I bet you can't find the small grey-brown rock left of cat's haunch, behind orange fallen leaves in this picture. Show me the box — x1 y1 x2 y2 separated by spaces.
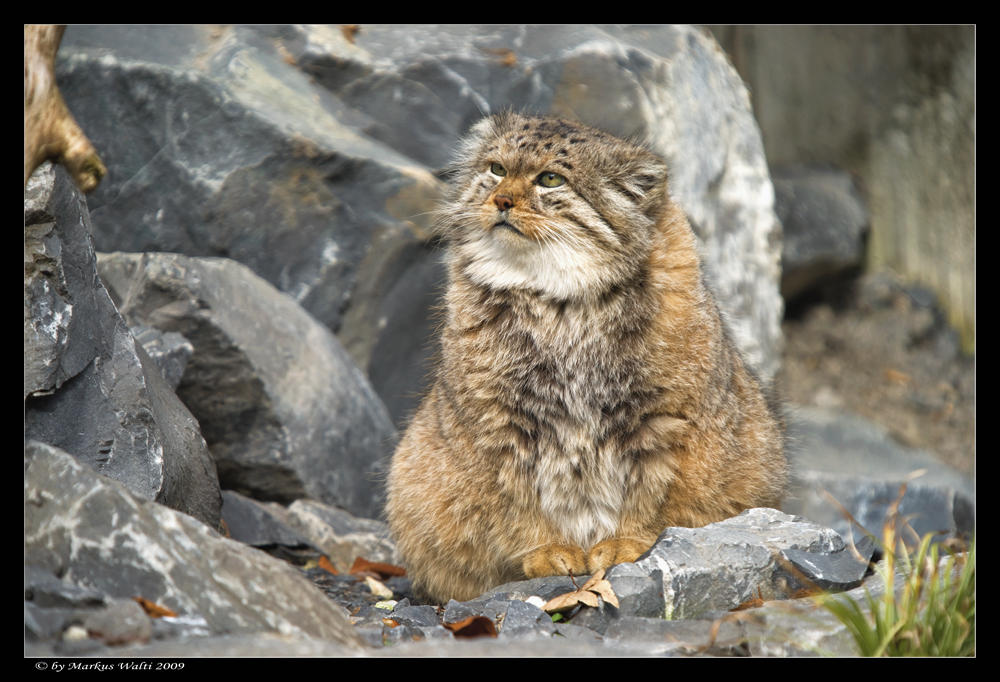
286 500 397 573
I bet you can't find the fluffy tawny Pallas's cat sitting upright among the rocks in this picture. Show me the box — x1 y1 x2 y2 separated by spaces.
387 113 787 603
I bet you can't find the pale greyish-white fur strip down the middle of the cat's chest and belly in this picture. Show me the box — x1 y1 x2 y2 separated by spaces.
482 300 634 547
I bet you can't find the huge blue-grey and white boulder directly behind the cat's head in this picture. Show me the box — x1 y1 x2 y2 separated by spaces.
58 26 783 432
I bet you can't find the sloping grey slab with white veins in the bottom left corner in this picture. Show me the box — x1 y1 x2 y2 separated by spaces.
24 442 360 647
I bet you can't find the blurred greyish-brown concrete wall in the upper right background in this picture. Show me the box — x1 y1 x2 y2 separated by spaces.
707 25 976 352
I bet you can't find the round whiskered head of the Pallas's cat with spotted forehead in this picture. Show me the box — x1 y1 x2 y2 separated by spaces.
444 114 666 300
